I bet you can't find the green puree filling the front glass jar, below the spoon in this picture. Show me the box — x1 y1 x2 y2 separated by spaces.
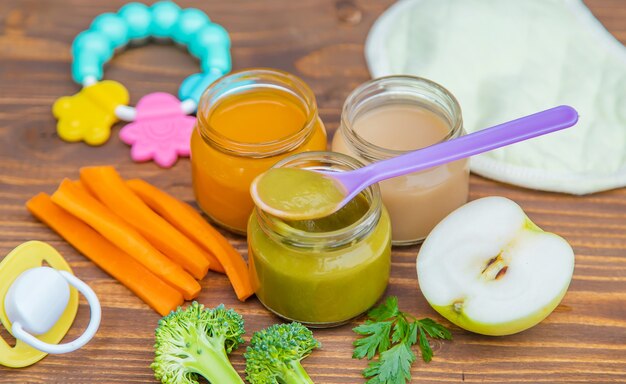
248 195 391 325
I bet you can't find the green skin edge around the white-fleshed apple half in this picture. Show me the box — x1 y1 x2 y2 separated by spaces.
418 198 573 336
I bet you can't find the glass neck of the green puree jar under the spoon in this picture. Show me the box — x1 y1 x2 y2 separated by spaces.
255 152 382 250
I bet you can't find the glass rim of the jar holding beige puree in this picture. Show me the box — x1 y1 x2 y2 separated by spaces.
337 75 464 161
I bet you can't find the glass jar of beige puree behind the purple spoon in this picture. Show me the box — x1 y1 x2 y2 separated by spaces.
332 76 469 245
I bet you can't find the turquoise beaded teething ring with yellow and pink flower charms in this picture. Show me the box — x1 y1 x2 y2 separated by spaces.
53 1 231 167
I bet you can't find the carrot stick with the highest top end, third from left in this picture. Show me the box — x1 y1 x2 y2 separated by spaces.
80 166 210 280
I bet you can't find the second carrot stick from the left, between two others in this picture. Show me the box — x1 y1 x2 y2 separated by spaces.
52 179 200 300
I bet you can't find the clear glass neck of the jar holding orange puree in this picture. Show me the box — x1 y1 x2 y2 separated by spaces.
196 68 318 158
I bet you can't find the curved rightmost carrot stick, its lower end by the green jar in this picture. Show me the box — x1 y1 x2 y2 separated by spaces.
126 179 254 301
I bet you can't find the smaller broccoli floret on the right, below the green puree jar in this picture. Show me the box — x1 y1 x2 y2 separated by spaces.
244 322 321 384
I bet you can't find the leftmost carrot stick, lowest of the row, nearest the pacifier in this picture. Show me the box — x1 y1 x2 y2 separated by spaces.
26 193 183 316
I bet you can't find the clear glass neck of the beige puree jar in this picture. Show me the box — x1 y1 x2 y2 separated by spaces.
338 76 465 162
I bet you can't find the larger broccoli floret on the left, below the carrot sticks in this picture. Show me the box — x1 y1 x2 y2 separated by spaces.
150 301 245 384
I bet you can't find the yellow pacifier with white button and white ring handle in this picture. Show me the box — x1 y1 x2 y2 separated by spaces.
0 241 101 368
